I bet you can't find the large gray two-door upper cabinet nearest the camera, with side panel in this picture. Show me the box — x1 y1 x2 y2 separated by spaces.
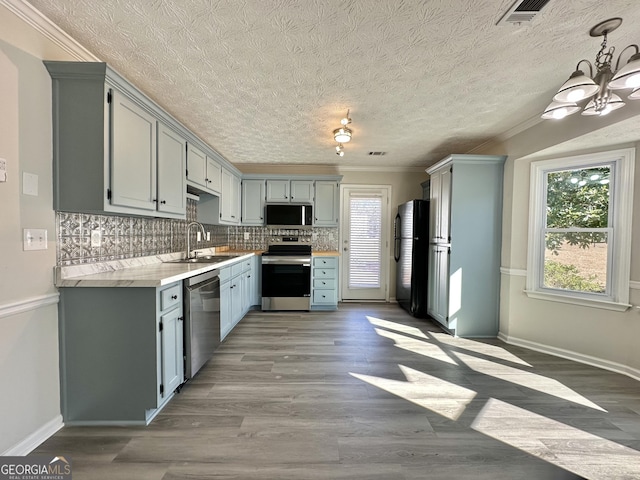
44 61 186 218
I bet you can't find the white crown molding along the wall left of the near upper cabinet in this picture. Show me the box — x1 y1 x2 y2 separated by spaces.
0 0 100 62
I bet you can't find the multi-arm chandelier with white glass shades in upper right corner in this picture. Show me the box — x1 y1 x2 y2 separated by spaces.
542 17 640 119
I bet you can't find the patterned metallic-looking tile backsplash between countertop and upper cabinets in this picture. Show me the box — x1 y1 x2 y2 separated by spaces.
56 199 338 266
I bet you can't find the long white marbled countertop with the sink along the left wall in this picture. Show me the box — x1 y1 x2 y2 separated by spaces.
55 252 255 287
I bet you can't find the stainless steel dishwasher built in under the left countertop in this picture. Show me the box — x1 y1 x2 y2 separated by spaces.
184 270 220 379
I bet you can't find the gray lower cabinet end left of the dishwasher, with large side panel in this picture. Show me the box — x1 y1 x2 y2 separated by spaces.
59 282 184 425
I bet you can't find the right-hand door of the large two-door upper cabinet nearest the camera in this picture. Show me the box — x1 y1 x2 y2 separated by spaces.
157 122 187 215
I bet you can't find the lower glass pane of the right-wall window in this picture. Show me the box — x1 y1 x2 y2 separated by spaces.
544 232 608 293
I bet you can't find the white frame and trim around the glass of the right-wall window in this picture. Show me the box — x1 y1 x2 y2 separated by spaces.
525 148 635 311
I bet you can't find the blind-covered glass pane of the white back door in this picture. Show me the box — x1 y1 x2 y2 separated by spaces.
348 197 382 288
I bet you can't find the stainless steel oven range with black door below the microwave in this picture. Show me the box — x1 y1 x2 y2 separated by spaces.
262 236 311 310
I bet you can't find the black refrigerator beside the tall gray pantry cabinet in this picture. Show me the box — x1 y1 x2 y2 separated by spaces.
393 200 429 318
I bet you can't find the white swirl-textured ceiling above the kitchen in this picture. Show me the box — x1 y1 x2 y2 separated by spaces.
22 0 640 167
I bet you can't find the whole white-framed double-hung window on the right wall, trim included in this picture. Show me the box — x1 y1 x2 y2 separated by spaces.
527 149 635 310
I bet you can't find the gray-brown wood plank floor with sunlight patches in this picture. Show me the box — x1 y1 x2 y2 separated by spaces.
33 304 640 480
